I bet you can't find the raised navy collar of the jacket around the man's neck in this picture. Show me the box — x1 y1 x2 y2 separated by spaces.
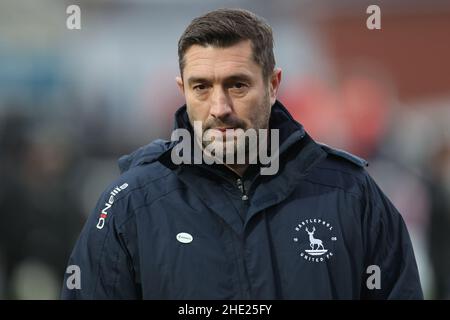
161 101 326 234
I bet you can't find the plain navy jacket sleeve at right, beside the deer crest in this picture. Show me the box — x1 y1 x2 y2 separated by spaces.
361 175 423 299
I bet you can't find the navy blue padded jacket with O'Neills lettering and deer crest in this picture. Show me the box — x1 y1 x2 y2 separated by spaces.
62 101 423 299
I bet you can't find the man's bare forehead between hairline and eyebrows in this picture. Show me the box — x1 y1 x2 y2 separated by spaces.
183 40 261 79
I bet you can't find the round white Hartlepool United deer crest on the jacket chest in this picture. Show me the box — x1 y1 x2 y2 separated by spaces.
293 218 337 263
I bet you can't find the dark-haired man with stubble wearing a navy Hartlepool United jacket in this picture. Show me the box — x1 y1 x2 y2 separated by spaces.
62 9 422 299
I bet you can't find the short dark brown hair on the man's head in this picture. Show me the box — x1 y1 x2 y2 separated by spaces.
178 9 275 79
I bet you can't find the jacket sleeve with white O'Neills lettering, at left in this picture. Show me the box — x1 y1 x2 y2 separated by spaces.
61 187 140 299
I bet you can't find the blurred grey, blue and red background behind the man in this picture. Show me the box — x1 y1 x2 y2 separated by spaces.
0 0 450 299
